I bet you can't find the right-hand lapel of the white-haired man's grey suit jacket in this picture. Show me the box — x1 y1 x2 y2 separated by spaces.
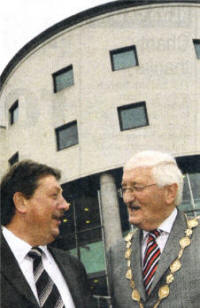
150 211 186 293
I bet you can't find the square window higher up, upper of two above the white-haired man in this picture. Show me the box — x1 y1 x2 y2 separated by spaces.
110 45 138 71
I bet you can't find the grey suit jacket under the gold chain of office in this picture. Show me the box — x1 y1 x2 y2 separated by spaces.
109 211 200 308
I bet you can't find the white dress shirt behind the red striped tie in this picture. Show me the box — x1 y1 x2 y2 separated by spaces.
142 208 177 264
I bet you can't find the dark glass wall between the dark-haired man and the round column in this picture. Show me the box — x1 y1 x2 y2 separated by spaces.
50 177 109 308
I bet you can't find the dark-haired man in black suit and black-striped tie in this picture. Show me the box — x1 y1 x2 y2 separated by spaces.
1 160 93 308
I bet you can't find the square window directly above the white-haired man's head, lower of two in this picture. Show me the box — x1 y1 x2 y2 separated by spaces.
118 102 149 131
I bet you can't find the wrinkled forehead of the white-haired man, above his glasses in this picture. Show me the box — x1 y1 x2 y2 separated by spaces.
122 167 153 185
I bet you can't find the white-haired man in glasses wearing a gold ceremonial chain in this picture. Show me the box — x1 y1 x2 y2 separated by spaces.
109 151 200 308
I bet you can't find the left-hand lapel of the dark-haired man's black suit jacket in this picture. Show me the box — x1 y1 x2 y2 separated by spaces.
1 234 38 306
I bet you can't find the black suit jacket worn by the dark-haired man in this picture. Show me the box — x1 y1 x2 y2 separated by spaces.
1 234 94 308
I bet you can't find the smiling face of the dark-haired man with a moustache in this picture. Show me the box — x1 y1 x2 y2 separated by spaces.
19 175 69 246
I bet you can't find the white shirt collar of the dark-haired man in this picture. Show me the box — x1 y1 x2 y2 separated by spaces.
2 226 49 264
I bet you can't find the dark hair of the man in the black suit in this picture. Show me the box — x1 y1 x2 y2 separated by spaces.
0 160 61 225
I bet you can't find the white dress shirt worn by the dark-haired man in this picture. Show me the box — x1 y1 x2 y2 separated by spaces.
2 227 75 308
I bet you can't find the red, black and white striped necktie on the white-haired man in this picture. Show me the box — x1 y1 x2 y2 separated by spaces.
143 230 161 294
